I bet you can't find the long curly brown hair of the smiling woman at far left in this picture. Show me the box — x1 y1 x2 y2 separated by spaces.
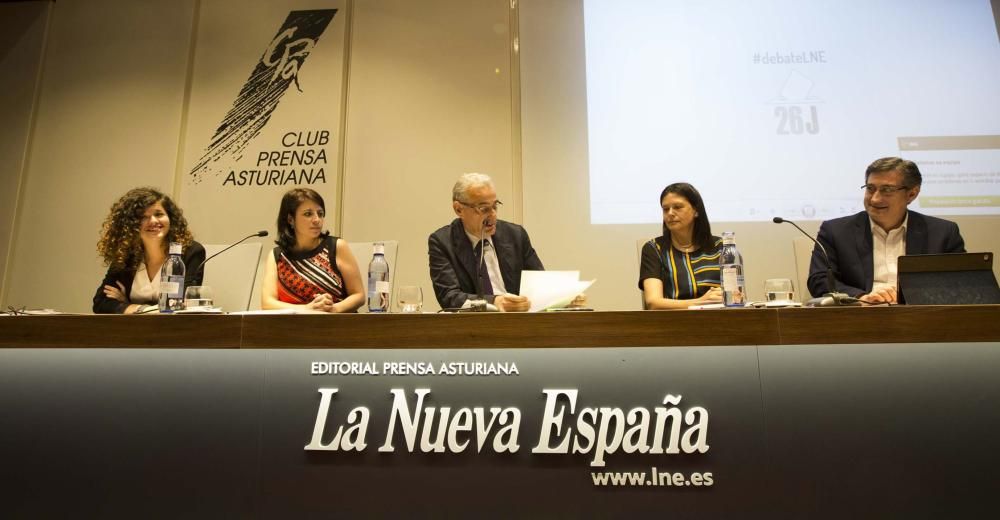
97 187 194 270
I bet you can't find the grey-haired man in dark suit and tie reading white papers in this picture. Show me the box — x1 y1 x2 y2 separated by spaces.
427 173 545 312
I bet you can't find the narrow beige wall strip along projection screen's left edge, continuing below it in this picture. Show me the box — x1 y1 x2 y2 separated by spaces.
520 1 644 309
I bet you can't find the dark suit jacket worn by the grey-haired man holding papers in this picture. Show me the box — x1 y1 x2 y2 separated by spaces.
427 219 545 309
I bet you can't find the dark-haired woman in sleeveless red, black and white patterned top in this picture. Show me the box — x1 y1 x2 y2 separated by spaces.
261 188 365 312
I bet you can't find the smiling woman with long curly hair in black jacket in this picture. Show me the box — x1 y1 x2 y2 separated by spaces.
94 188 205 314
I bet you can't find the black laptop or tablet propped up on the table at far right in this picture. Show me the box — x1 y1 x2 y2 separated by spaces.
896 253 1000 305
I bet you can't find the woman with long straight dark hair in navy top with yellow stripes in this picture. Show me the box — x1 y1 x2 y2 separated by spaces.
639 182 722 309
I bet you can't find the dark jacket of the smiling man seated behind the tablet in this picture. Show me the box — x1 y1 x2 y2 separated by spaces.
809 211 965 297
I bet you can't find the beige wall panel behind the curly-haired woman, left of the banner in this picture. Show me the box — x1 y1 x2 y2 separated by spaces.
4 0 195 312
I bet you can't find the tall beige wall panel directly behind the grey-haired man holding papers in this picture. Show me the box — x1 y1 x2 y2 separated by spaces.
342 0 519 309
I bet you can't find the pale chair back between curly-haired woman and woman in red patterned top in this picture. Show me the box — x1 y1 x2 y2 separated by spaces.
202 243 261 312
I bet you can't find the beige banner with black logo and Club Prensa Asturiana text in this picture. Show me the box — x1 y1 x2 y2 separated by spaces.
180 0 346 242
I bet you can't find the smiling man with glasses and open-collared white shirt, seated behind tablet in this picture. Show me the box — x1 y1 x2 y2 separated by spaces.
809 157 965 303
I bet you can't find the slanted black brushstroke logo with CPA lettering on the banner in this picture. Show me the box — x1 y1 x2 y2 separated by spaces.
189 9 337 184
